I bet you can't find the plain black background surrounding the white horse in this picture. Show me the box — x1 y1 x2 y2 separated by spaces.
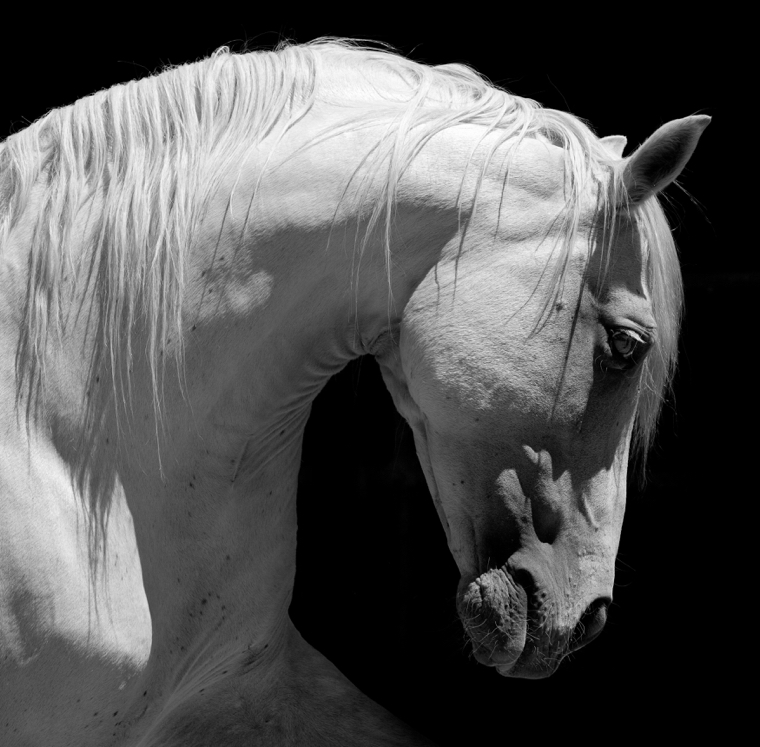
0 16 744 745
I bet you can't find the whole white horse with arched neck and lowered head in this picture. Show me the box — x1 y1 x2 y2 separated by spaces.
0 41 709 747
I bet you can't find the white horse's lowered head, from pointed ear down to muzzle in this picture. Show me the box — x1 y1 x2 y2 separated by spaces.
378 116 709 678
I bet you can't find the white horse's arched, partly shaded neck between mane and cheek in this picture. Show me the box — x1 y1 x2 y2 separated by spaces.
125 120 472 646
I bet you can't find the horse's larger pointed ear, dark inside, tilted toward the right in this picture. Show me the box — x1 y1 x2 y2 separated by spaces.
623 114 710 205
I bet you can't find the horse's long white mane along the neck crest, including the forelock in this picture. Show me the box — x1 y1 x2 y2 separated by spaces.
0 39 682 462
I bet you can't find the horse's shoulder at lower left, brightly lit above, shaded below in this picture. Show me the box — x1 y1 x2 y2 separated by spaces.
0 424 150 745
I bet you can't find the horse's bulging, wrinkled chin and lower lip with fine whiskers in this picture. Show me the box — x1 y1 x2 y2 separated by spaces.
457 568 561 679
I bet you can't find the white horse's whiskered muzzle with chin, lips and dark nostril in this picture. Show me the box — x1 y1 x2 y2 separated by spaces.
457 566 611 679
